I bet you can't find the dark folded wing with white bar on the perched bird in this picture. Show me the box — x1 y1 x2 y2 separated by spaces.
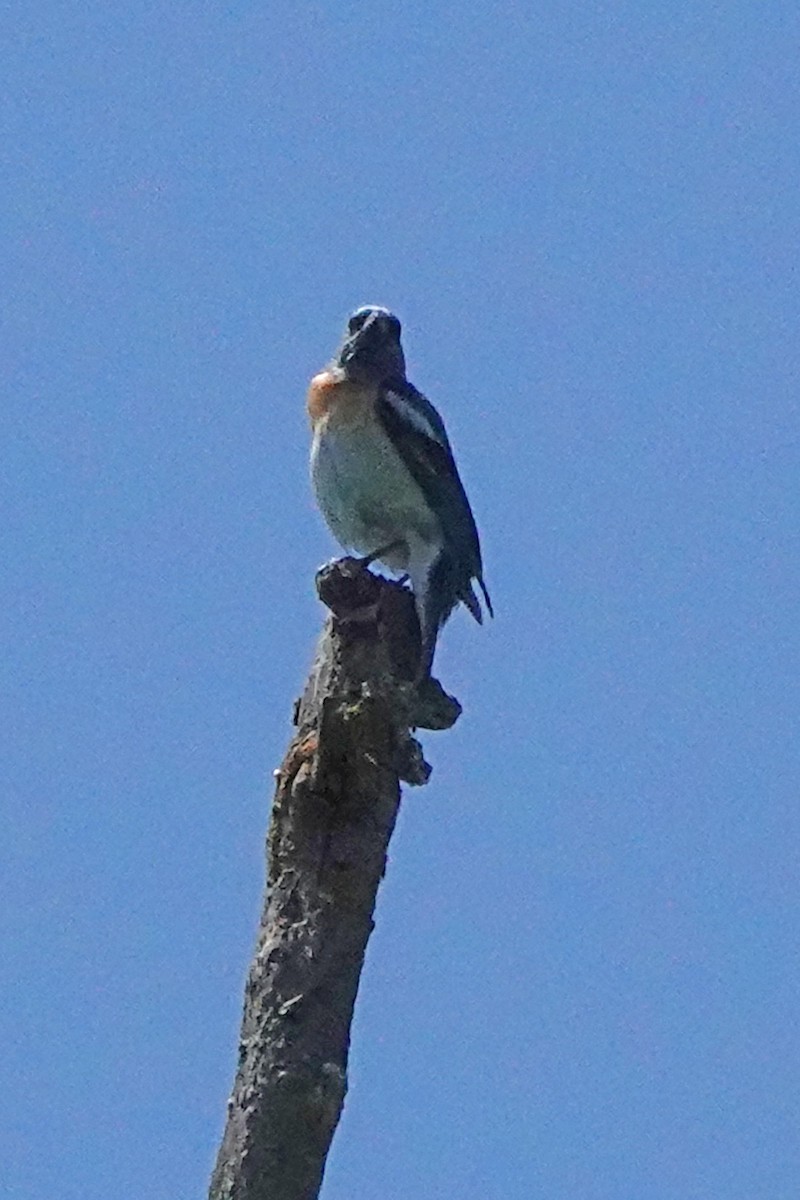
377 380 491 597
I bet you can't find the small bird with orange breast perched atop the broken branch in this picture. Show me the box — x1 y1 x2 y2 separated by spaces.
307 305 494 683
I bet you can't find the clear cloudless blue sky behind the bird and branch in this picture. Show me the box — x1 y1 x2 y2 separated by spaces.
0 0 800 1200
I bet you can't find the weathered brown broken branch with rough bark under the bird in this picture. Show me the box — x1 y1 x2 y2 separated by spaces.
210 559 461 1200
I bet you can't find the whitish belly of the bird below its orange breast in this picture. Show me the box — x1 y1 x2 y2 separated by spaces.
311 412 440 571
